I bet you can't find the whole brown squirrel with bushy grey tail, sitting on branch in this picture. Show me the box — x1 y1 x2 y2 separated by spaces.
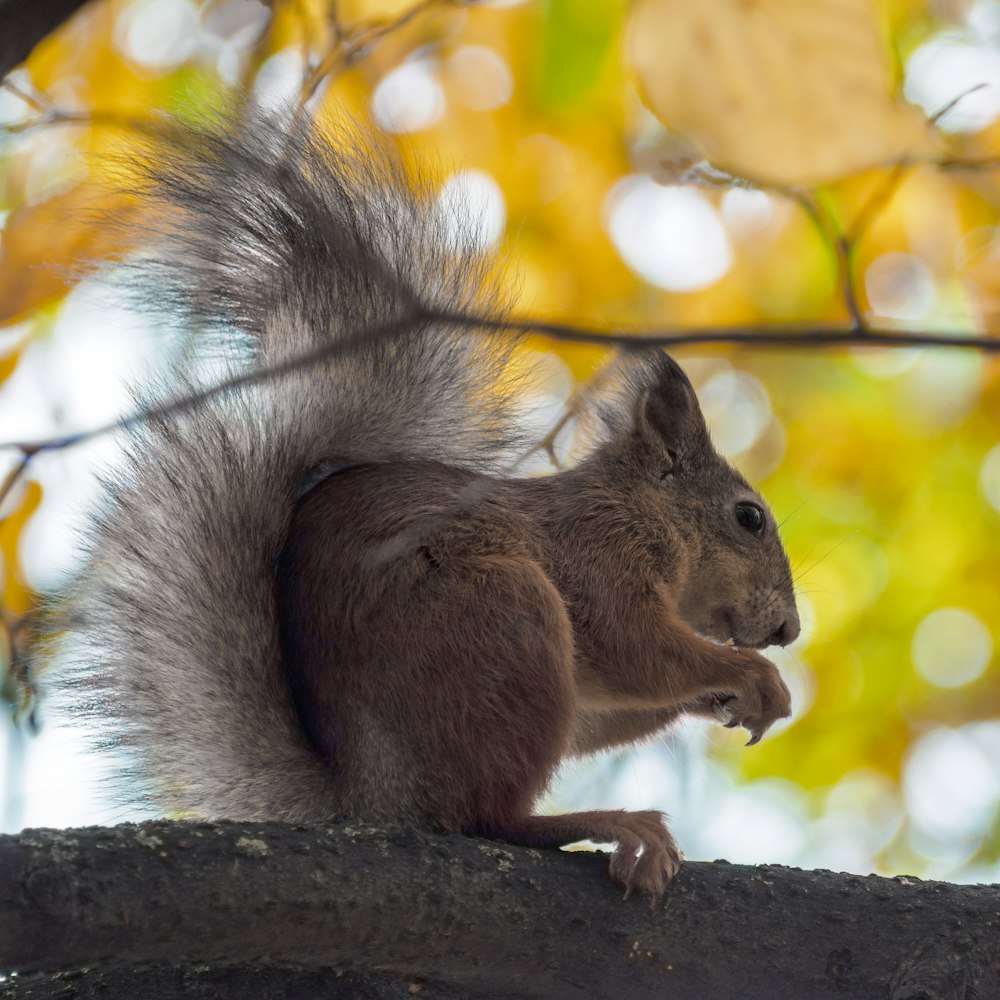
55 111 799 898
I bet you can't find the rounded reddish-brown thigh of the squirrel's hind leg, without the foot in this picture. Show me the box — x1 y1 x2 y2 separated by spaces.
316 544 576 832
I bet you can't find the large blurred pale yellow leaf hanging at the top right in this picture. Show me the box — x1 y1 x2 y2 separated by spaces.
629 0 929 186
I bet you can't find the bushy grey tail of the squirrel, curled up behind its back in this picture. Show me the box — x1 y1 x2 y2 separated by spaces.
57 107 513 821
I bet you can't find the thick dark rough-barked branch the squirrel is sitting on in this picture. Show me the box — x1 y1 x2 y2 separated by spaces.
0 822 1000 1000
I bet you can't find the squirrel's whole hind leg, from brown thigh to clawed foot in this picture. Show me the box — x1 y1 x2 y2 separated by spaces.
341 539 680 896
